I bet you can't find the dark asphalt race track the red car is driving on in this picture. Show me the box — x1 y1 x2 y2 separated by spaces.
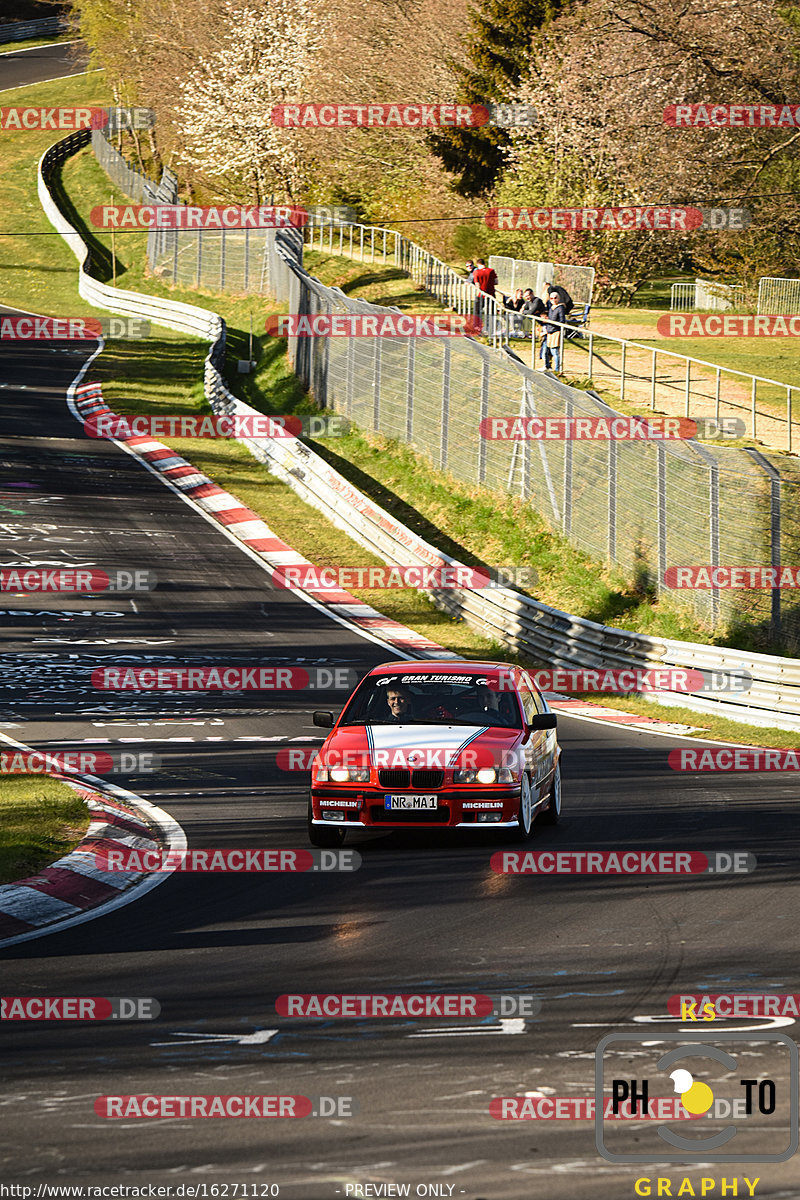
0 42 800 1200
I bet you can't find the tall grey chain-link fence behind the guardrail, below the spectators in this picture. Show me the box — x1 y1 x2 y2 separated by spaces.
90 136 800 652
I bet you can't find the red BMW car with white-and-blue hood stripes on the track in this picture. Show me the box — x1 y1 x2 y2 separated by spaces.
308 659 561 847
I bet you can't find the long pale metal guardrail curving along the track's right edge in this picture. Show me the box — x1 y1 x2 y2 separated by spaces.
40 131 800 731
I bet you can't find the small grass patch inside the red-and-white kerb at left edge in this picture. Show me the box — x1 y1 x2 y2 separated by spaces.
0 775 89 883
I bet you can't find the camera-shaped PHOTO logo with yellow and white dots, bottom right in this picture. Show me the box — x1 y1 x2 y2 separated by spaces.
595 1028 800 1163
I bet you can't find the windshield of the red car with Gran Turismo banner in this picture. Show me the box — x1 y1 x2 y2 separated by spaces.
341 672 522 730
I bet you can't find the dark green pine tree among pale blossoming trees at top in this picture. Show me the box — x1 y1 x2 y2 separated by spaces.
429 0 559 197
